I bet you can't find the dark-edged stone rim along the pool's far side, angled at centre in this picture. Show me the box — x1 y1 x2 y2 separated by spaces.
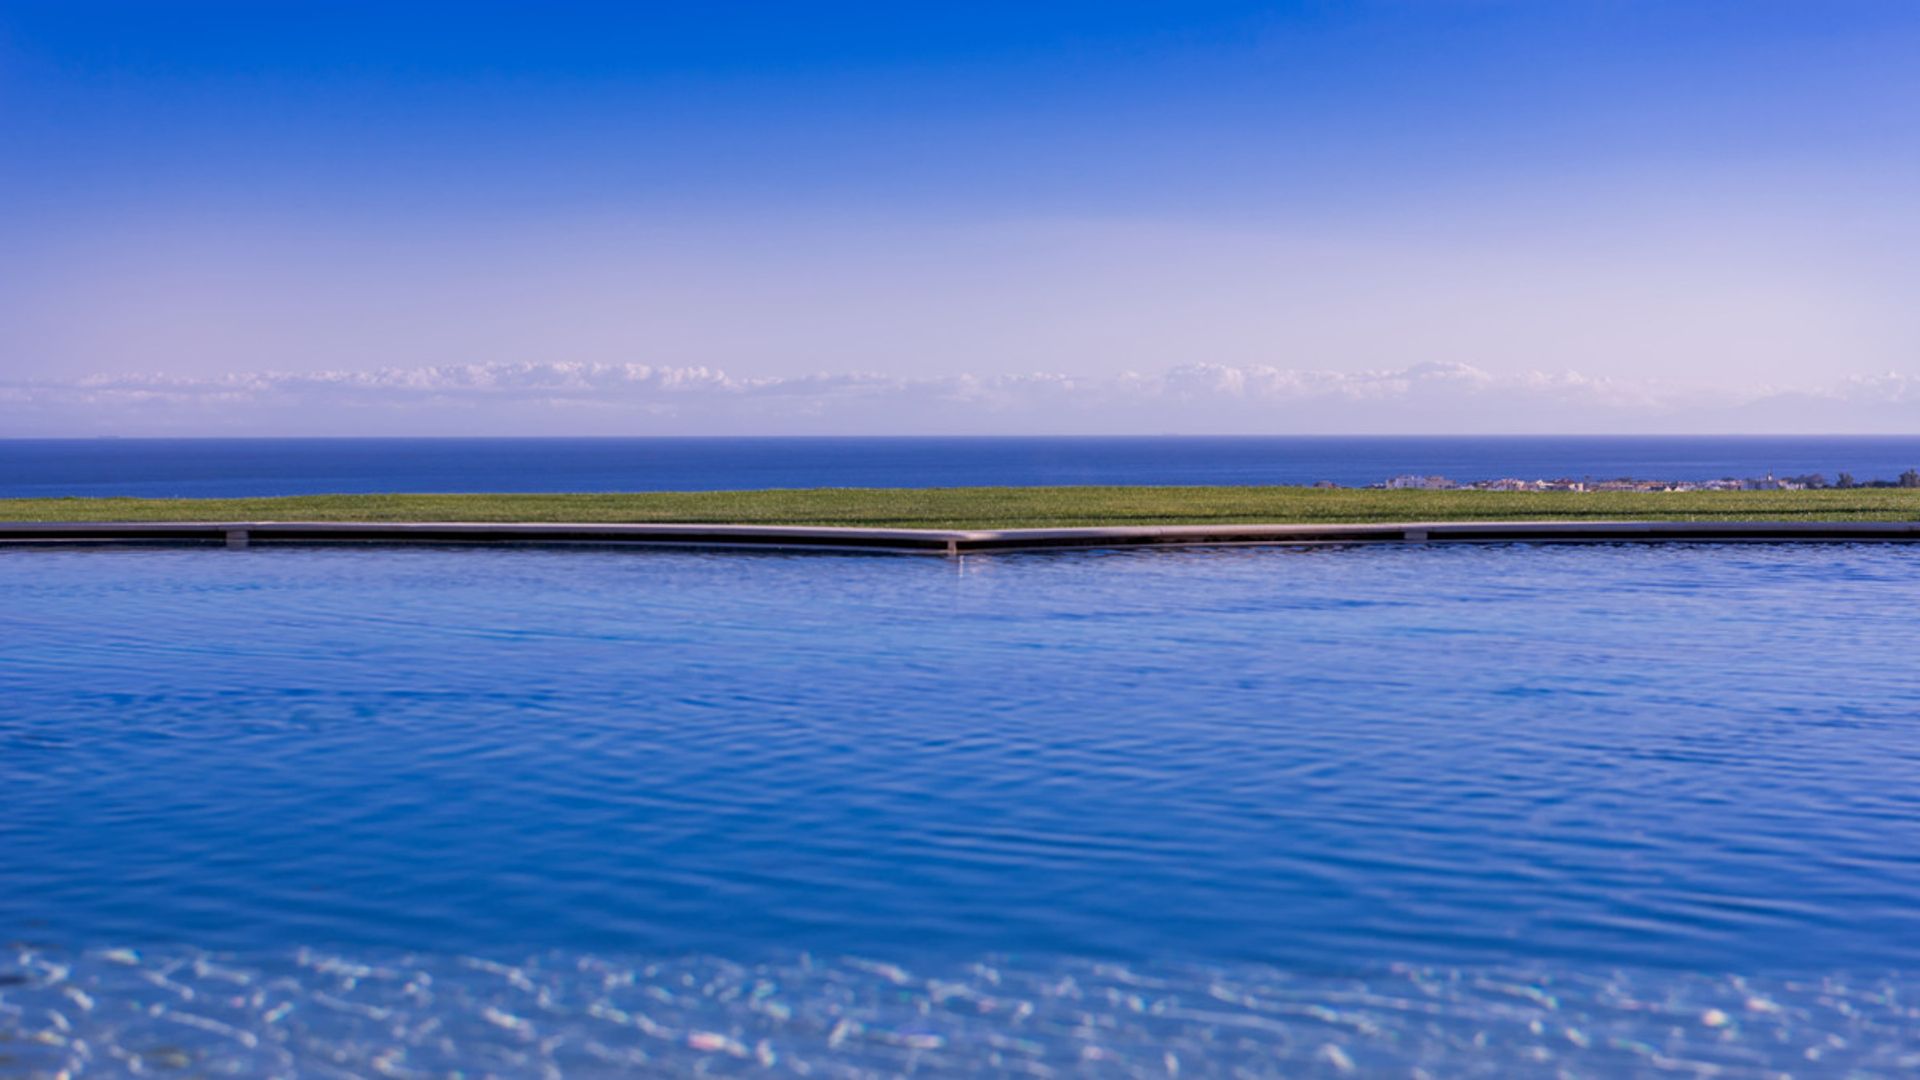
0 521 1920 555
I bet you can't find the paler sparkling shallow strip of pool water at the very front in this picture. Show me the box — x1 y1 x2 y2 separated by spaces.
11 949 1920 1076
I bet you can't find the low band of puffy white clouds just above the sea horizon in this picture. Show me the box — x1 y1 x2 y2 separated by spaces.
0 363 1920 436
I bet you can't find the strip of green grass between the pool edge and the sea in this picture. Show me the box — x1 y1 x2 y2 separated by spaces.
0 488 1920 528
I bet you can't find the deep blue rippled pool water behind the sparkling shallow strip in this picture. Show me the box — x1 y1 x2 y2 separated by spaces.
0 546 1920 972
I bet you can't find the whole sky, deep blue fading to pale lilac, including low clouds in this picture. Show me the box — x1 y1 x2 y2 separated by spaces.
0 0 1920 434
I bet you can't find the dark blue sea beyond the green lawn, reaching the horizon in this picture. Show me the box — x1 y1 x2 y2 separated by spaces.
11 436 1920 498
